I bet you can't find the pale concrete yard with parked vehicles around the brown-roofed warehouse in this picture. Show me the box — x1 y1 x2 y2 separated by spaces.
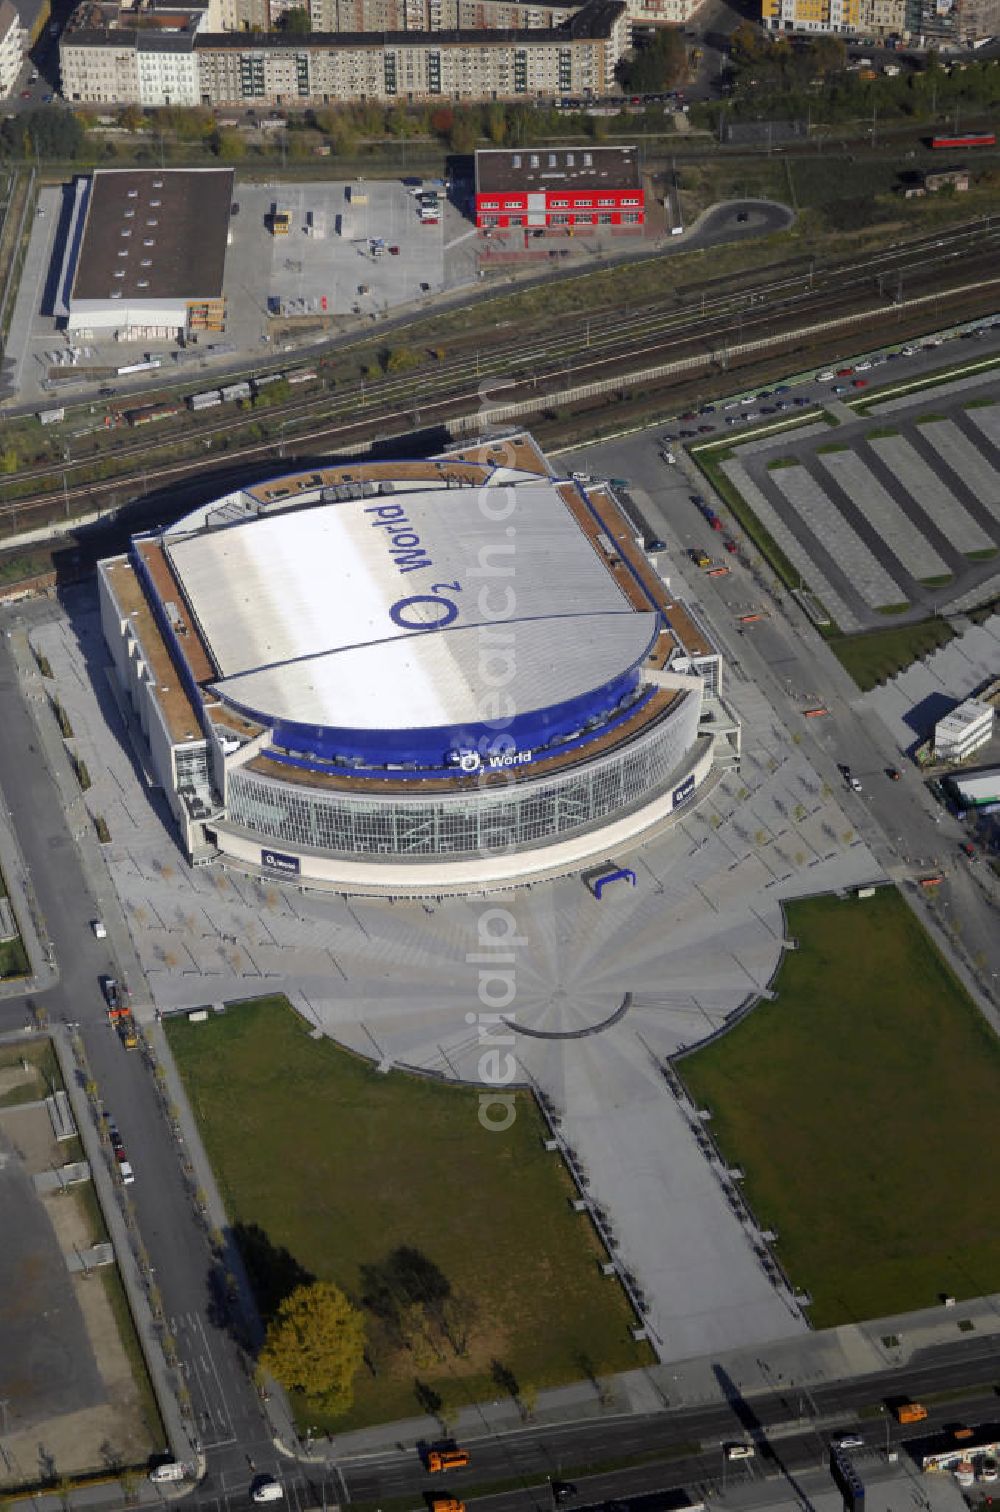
0 180 478 404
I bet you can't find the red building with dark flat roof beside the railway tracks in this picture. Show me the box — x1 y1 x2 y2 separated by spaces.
475 147 646 234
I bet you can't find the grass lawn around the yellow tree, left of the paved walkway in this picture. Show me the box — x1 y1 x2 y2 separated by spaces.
168 998 651 1429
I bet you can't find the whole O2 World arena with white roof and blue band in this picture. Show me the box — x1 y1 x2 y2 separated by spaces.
98 435 740 895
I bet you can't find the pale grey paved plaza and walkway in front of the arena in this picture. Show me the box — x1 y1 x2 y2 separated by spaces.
32 590 879 1359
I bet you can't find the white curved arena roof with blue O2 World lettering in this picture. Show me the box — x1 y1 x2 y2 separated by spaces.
163 481 657 729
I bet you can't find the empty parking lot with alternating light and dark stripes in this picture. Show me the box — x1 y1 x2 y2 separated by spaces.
720 375 1000 634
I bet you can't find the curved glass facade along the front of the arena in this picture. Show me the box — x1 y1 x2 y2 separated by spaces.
227 692 700 856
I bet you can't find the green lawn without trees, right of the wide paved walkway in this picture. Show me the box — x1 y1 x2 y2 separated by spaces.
679 888 1000 1328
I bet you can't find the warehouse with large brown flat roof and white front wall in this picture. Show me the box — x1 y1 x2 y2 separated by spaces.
56 168 234 340
